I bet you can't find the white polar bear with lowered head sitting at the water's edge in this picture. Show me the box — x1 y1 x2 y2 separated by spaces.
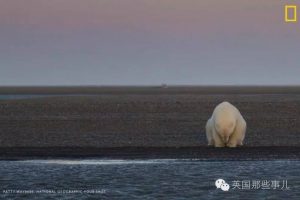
206 101 247 147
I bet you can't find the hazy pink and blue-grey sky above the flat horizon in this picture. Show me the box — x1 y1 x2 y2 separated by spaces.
0 0 300 86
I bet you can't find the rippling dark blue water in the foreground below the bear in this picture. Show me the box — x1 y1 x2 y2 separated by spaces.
0 159 300 200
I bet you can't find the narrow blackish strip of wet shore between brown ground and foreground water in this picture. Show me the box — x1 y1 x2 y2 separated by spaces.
0 146 300 161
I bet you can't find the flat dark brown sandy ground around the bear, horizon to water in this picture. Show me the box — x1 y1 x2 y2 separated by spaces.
0 87 300 159
